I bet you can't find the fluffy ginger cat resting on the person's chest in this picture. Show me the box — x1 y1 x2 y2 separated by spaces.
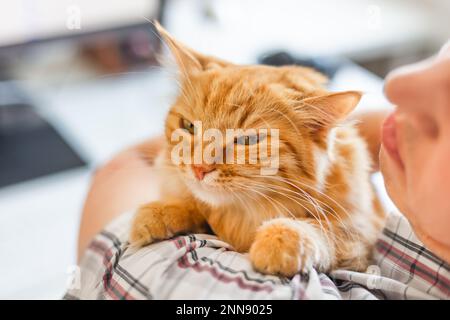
129 25 384 277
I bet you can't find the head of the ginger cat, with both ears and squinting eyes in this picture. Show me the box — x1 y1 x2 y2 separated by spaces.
156 23 359 205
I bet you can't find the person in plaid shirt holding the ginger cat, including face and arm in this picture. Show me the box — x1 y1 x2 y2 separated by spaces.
65 42 450 299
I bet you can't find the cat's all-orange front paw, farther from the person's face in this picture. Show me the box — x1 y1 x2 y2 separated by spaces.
129 201 191 247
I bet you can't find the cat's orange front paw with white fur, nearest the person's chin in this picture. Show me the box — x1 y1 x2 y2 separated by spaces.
249 218 330 277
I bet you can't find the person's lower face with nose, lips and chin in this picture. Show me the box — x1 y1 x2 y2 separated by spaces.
380 42 450 262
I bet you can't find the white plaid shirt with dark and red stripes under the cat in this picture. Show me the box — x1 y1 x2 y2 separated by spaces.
64 213 450 299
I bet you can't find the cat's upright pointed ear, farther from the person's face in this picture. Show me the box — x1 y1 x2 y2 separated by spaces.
154 21 231 74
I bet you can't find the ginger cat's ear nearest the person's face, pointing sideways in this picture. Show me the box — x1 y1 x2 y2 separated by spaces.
298 91 362 126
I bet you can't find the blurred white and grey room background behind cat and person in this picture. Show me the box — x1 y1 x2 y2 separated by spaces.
0 0 450 299
